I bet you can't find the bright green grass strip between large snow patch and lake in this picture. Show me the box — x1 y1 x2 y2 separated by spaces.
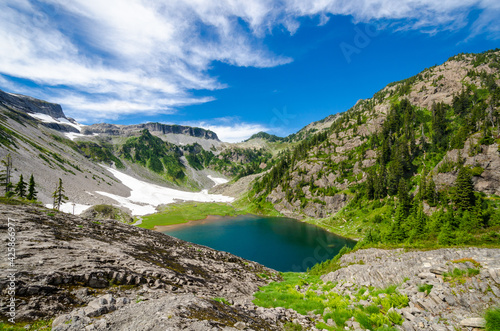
138 202 245 229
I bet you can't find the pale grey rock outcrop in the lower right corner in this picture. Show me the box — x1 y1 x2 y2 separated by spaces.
321 248 500 331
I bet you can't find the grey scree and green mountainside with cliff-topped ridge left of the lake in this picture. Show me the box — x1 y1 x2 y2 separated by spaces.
0 87 282 213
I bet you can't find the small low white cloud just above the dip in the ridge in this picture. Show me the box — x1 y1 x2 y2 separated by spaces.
184 117 269 143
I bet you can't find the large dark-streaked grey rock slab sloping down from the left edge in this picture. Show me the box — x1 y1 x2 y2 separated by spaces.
0 205 308 330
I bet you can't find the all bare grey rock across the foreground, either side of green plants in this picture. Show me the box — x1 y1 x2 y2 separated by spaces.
0 205 500 331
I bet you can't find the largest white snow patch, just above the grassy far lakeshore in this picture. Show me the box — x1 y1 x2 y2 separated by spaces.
95 167 234 216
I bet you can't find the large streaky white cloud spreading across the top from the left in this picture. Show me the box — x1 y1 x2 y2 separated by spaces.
0 0 500 121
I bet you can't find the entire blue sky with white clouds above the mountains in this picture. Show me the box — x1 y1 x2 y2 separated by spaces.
0 0 500 142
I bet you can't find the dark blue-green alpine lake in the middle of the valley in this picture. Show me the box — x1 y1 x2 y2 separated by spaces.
163 215 356 272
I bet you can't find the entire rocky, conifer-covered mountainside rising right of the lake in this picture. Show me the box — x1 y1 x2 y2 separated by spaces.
251 50 500 245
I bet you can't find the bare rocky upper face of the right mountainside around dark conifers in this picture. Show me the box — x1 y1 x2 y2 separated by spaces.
255 50 500 218
